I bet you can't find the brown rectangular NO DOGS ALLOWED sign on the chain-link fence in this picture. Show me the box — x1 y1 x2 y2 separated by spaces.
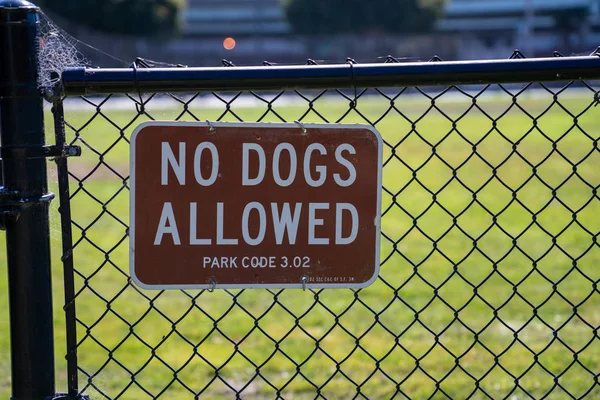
130 122 382 289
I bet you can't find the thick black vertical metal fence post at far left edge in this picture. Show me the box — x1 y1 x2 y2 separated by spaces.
0 0 55 400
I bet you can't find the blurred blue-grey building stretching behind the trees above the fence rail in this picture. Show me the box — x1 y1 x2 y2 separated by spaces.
42 0 600 66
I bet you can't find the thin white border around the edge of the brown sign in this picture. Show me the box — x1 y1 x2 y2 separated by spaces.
129 121 383 290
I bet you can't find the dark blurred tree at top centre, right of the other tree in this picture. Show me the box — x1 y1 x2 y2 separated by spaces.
283 0 444 35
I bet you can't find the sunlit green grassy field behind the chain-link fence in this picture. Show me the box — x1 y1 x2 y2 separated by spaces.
0 85 600 399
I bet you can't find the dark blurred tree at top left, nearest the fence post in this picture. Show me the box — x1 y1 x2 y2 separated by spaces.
37 0 183 36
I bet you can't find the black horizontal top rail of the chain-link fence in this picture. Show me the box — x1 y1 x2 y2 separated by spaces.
60 55 600 96
